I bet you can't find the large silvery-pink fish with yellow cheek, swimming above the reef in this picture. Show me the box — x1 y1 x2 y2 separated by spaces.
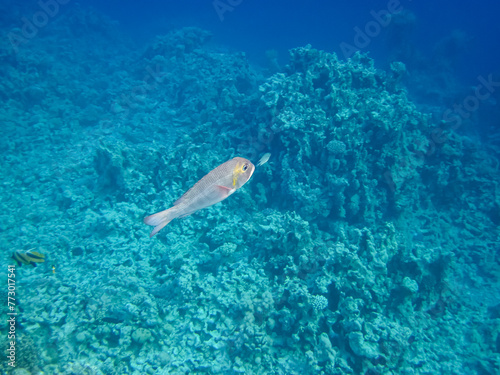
144 157 255 238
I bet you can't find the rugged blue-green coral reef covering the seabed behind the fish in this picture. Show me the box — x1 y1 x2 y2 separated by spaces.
0 4 500 375
